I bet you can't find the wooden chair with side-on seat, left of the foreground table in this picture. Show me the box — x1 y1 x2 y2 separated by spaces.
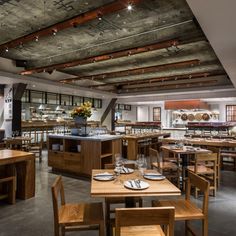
52 176 104 236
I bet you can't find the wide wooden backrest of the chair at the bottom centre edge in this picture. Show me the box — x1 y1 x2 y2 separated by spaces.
115 207 175 236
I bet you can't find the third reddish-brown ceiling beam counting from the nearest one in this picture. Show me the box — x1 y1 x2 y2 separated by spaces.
60 59 200 83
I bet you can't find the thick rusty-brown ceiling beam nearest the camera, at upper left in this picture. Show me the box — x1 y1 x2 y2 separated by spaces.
0 0 142 50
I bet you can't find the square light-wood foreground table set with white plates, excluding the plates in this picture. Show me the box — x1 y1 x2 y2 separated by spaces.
91 169 181 207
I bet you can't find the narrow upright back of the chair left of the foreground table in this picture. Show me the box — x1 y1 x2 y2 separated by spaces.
51 176 65 228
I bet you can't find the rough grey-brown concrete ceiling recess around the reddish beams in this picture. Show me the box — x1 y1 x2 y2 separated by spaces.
0 0 233 95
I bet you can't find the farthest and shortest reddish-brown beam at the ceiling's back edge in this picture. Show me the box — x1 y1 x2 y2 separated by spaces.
114 79 217 93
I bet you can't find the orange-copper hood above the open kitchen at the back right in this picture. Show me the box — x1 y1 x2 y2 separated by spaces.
165 100 209 110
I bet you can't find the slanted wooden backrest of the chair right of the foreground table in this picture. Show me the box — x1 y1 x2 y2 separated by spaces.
185 171 210 216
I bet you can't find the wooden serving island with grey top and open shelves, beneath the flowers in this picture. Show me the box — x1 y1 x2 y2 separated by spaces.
48 134 122 176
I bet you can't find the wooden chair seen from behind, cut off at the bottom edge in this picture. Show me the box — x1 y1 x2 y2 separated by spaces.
115 207 175 236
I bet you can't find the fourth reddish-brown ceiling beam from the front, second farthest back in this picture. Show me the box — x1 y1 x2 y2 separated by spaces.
87 71 225 88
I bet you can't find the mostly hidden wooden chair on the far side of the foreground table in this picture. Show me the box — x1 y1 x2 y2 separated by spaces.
104 163 143 235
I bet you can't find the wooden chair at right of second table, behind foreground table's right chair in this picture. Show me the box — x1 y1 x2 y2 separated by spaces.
187 153 218 197
